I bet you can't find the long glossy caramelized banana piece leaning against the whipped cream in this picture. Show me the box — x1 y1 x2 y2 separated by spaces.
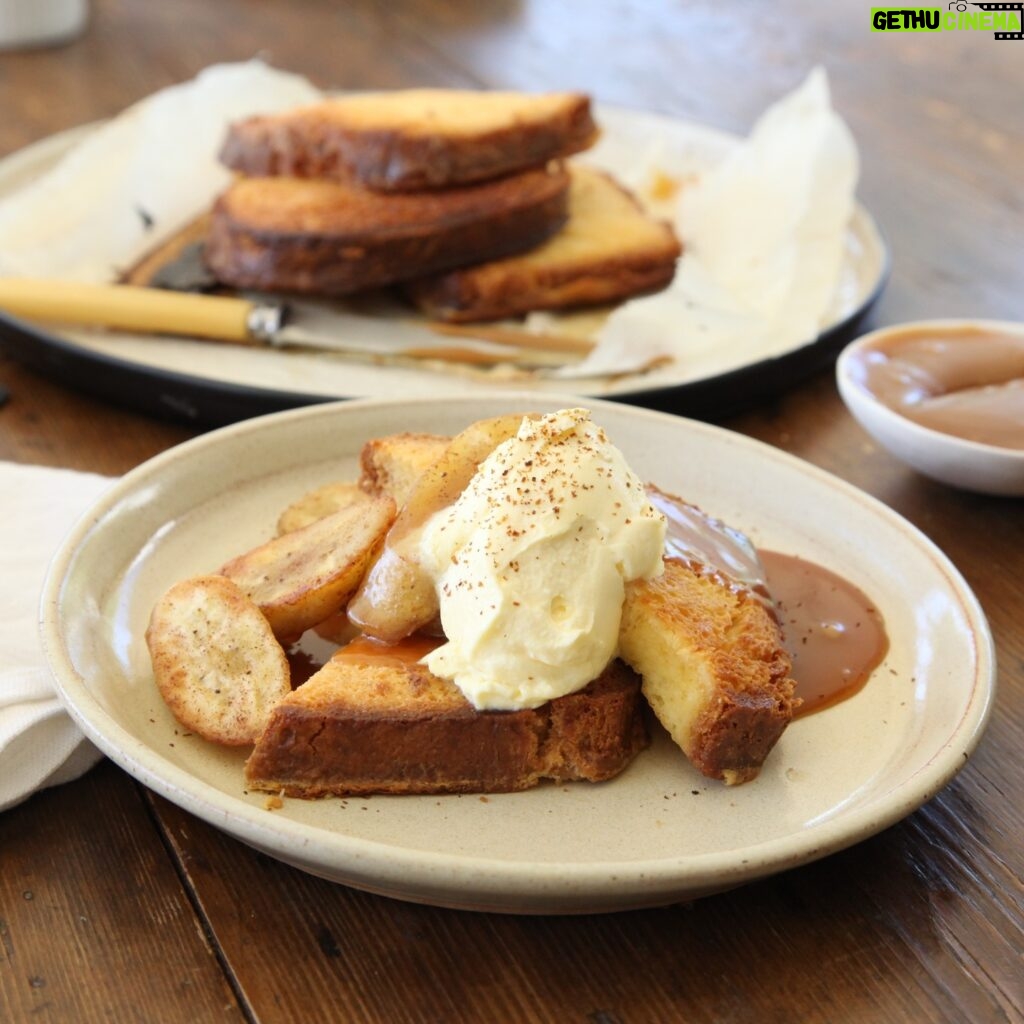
348 413 524 643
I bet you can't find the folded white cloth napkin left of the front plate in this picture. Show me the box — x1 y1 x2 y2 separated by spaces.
0 462 111 811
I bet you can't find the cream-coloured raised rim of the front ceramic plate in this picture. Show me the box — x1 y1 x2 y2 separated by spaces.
40 392 995 912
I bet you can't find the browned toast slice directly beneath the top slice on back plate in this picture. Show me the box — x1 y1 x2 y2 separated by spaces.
205 165 568 295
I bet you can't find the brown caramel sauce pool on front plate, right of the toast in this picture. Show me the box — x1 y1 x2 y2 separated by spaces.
760 551 889 718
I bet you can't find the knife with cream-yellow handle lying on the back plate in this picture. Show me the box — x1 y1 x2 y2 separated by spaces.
0 278 586 367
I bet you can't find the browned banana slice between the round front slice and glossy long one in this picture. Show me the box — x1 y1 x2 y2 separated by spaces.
220 498 396 643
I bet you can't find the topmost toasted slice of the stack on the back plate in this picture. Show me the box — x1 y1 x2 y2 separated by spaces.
220 89 597 191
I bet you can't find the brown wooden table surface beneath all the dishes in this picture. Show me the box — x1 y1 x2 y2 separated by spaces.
0 0 1024 1024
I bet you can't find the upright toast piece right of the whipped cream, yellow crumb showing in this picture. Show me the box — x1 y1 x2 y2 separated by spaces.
618 558 797 783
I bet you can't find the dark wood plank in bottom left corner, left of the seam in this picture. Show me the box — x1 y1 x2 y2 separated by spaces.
0 763 244 1024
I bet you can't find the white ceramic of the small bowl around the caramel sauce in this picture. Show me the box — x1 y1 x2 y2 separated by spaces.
836 319 1024 497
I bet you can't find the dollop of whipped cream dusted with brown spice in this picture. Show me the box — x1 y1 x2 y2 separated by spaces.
420 409 666 710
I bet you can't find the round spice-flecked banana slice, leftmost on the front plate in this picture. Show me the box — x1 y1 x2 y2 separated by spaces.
145 575 292 745
